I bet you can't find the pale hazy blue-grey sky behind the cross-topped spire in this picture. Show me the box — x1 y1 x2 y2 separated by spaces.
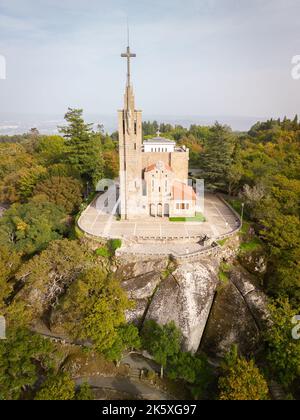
0 0 300 124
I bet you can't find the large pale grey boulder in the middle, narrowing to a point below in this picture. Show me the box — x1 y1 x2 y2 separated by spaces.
146 259 219 352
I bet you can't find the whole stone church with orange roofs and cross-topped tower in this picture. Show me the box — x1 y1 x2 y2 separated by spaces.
118 47 196 220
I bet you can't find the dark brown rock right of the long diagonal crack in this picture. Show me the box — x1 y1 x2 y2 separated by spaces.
200 266 268 358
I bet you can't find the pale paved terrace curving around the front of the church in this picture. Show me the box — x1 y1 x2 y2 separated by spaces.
78 189 239 243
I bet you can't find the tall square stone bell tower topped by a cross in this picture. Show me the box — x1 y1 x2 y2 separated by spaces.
118 45 142 220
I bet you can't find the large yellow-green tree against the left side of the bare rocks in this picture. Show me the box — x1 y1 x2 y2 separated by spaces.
53 267 133 358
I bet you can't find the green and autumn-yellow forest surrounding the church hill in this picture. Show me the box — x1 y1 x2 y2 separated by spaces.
0 109 300 400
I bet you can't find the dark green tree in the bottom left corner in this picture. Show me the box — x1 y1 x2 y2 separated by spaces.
0 328 54 400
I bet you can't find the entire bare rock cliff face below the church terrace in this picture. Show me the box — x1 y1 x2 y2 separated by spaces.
117 249 268 358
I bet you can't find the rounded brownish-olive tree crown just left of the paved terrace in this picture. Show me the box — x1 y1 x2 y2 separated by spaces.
34 176 82 214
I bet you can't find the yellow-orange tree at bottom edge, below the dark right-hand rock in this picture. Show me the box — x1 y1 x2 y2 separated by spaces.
219 347 269 401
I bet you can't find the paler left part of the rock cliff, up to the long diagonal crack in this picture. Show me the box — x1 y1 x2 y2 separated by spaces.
122 259 218 352
